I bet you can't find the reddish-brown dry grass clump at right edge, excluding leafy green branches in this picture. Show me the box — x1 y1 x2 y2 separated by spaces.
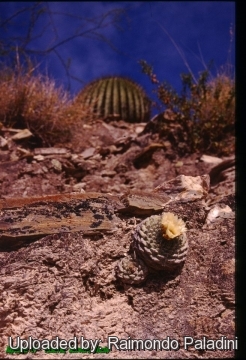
189 73 235 155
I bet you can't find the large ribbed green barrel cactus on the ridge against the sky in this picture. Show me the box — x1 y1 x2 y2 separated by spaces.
78 76 150 123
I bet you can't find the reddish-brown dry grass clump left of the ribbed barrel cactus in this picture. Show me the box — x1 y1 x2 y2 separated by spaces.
0 66 94 146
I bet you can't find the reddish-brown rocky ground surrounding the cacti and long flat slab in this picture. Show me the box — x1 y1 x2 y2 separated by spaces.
0 116 235 359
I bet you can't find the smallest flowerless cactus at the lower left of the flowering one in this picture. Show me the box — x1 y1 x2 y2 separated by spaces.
115 255 148 284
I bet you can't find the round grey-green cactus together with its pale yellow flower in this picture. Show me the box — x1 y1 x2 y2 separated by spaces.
133 213 188 271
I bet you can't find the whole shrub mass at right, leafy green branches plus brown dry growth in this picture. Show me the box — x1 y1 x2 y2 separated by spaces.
140 60 235 156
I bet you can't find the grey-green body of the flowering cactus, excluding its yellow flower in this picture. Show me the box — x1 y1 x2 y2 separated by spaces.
133 215 188 270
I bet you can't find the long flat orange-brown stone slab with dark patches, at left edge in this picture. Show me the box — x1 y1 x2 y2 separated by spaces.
0 193 120 248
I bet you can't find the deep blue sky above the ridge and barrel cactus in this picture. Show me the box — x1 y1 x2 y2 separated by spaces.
0 1 235 115
